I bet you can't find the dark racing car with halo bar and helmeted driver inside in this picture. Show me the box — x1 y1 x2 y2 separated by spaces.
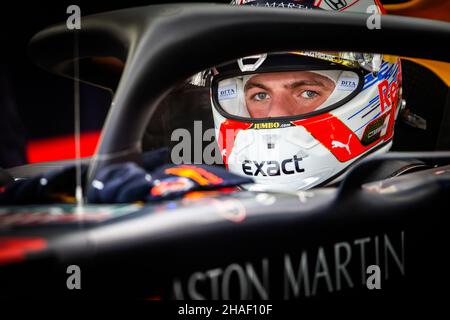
0 1 450 303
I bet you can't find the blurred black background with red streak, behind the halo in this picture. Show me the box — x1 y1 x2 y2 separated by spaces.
0 0 445 168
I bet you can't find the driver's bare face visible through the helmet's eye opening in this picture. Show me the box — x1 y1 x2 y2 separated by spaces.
244 71 335 118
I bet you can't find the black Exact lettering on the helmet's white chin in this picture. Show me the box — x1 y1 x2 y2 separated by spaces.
242 155 305 177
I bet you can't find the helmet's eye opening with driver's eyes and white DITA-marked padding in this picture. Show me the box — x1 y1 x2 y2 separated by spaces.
211 57 364 120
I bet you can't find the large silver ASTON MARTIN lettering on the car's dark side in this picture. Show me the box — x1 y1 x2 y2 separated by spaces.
171 230 405 300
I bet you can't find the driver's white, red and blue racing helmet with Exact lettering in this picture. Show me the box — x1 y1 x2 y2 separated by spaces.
208 0 401 190
